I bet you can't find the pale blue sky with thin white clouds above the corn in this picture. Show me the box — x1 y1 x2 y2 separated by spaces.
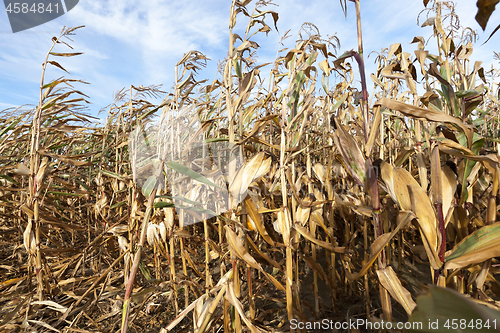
0 0 500 117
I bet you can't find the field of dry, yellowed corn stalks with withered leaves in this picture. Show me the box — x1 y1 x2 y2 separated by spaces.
0 0 500 332
